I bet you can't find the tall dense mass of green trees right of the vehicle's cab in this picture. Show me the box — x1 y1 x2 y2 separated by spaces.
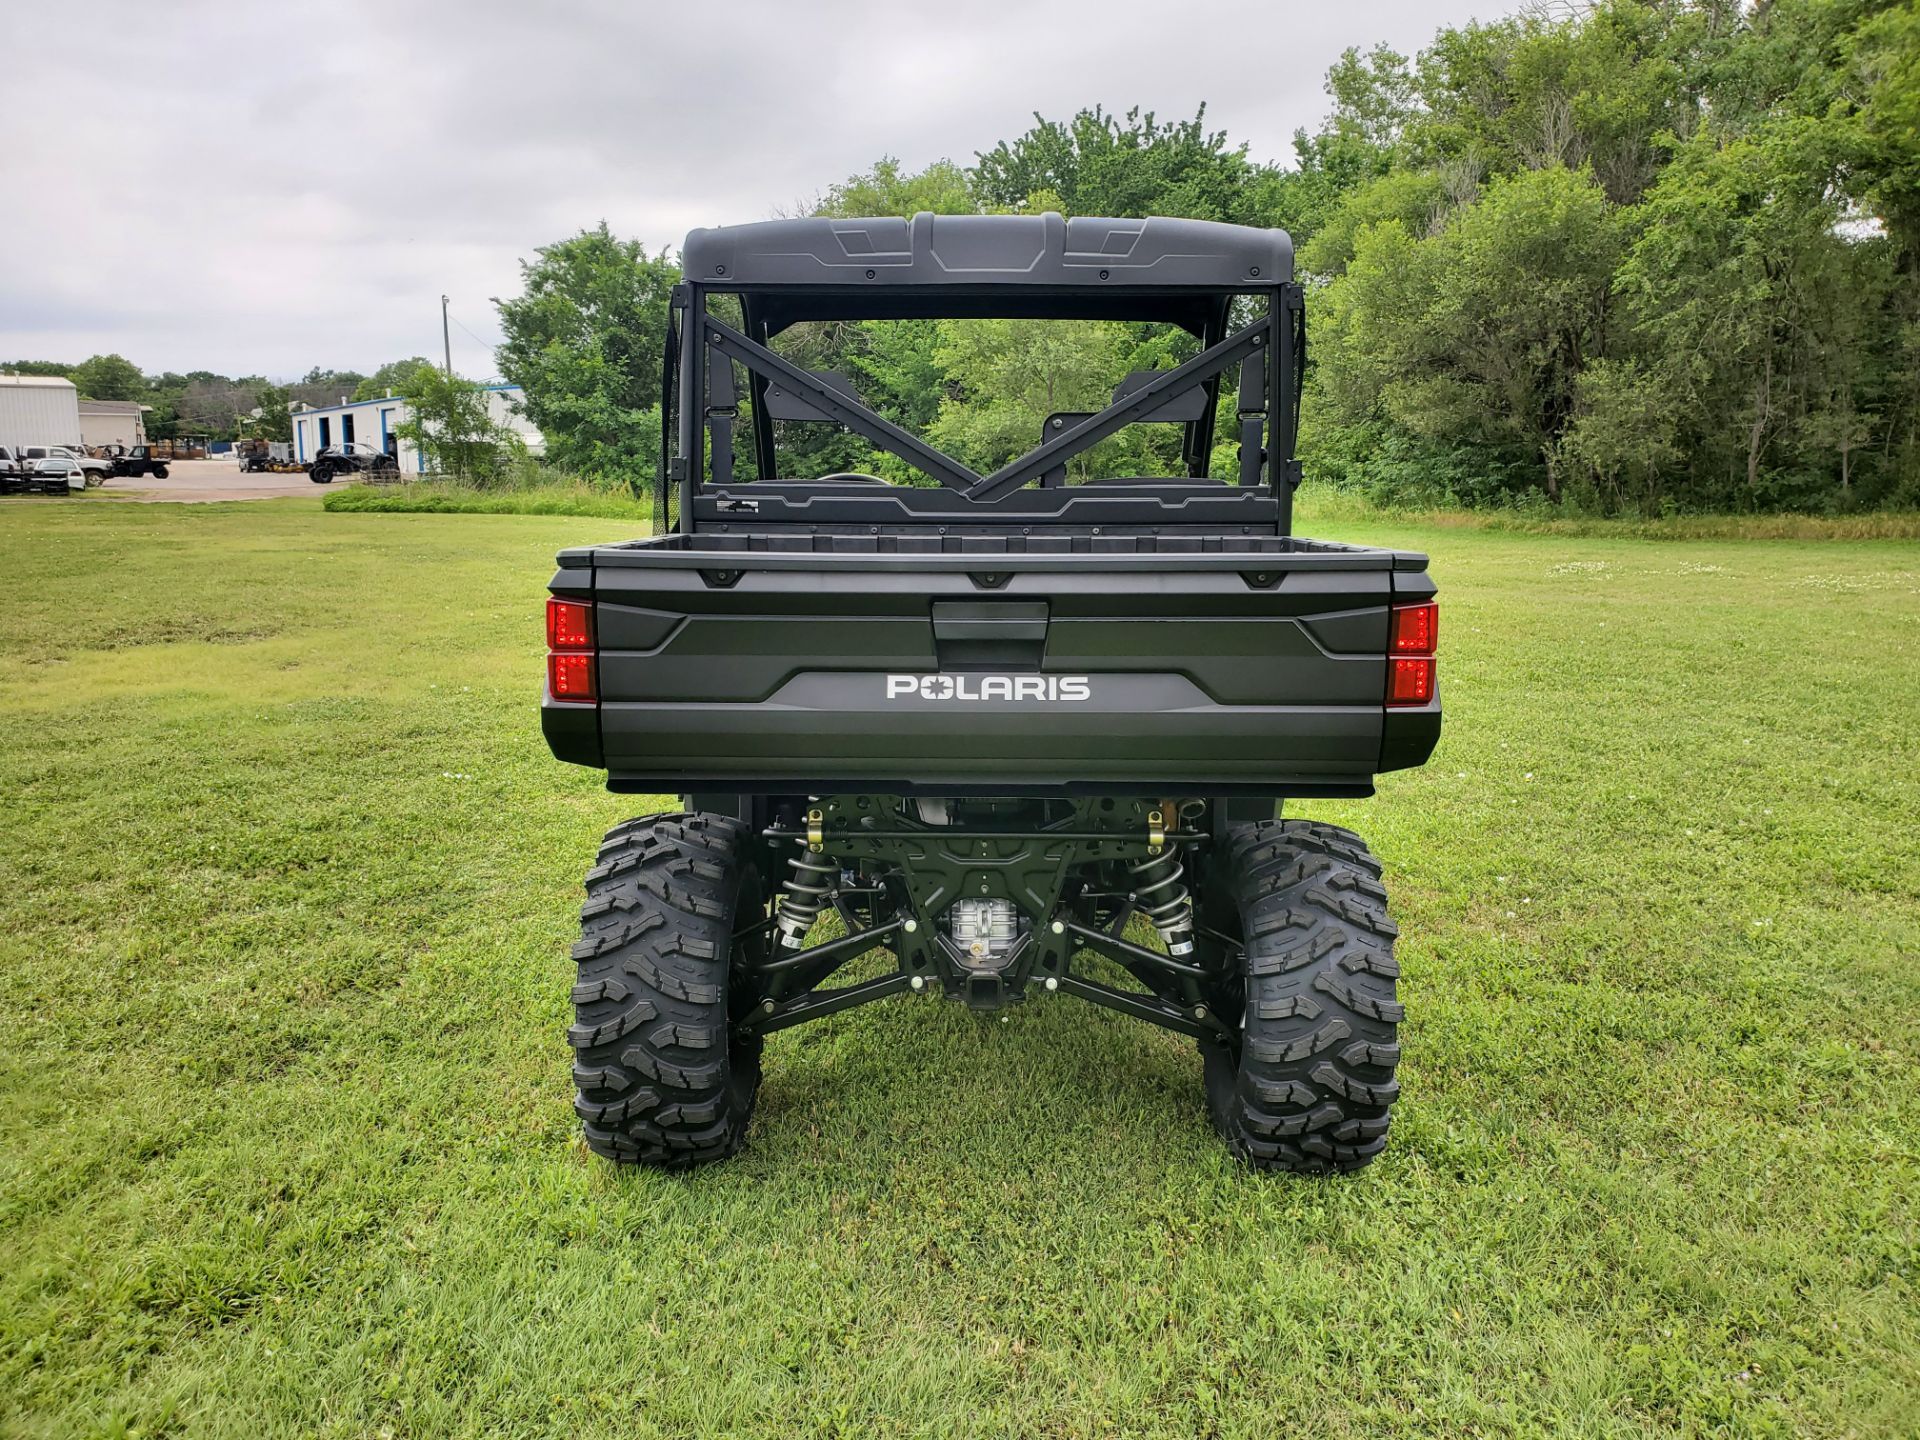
1290 0 1920 507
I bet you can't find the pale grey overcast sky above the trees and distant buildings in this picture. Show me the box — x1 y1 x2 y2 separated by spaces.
0 0 1507 378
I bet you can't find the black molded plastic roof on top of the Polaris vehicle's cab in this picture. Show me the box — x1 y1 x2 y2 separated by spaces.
680 211 1294 292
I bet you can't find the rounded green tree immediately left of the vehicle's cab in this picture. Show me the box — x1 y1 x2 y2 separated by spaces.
493 223 680 484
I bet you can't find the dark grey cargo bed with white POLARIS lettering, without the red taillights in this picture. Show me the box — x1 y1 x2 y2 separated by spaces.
543 530 1440 797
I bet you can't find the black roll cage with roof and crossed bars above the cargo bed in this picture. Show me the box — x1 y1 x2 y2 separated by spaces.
655 213 1306 536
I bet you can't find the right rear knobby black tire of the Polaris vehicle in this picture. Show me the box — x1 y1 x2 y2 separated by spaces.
1200 820 1404 1175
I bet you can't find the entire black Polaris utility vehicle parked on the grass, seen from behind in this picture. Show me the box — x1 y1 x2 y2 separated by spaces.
541 215 1440 1171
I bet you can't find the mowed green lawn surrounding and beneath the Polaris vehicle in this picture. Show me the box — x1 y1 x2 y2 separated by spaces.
0 497 1920 1438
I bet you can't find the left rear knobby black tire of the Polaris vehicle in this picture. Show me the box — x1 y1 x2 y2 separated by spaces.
566 814 766 1169
